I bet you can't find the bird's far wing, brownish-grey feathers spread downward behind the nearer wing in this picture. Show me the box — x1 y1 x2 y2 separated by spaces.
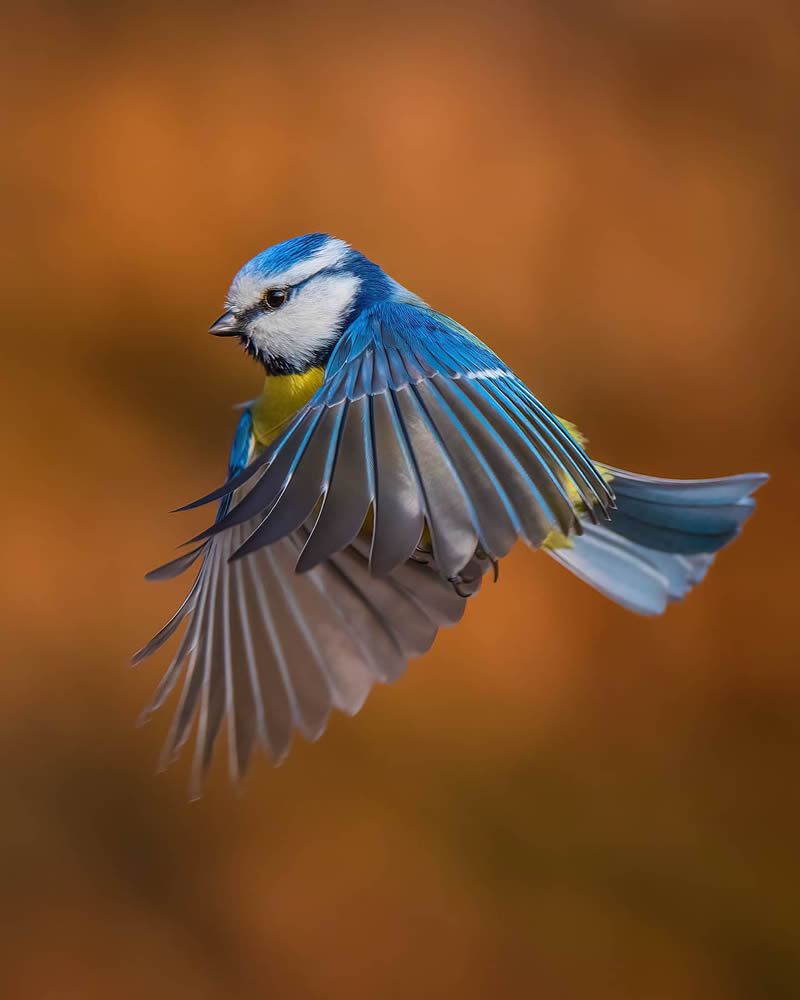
133 413 468 794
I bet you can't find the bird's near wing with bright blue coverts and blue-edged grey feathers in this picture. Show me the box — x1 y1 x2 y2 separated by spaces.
190 302 613 577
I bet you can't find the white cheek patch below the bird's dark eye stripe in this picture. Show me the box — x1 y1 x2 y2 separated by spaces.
248 274 361 367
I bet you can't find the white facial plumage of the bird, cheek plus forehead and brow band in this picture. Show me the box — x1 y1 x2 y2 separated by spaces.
228 239 361 370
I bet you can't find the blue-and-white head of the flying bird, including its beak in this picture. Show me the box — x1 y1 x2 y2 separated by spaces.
209 233 410 375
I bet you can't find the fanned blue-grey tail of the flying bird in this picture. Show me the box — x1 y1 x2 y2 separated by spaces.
547 466 769 615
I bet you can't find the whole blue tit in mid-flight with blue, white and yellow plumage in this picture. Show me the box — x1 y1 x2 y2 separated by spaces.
132 233 768 795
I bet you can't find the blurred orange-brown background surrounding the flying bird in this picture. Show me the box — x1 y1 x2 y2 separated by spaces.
0 0 800 1000
